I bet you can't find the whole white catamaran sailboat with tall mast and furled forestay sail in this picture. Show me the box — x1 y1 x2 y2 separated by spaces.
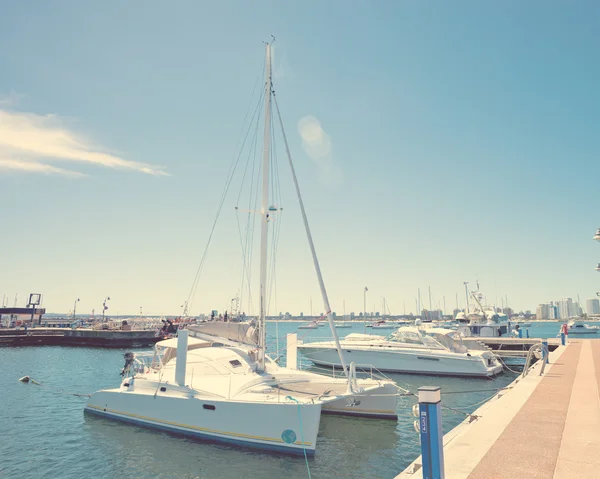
85 44 397 454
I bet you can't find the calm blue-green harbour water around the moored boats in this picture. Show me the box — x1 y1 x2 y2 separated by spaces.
0 323 559 479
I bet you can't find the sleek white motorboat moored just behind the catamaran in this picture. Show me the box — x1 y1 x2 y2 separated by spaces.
298 327 502 377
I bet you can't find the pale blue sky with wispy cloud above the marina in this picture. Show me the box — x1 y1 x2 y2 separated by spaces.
0 0 600 315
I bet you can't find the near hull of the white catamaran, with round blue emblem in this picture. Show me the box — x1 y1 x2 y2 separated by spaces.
85 389 321 454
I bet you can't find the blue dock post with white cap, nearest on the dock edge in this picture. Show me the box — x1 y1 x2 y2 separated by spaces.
418 386 445 479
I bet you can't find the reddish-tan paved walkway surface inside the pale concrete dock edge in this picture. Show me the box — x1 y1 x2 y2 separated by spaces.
468 340 600 479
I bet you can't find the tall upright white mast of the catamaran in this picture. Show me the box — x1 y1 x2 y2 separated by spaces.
258 43 272 370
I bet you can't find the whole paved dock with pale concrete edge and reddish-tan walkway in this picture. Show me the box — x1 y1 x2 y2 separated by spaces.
396 339 600 479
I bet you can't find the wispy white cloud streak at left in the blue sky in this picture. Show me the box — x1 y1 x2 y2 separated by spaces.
0 109 168 178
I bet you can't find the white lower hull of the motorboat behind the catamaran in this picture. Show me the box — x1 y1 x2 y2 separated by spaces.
298 346 502 377
